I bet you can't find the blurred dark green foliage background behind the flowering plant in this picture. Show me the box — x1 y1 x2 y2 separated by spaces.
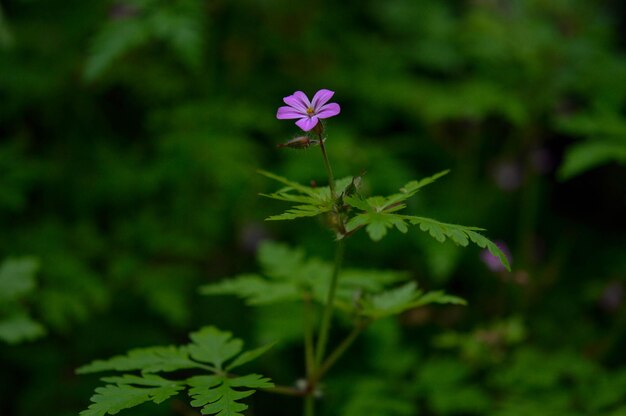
0 0 626 416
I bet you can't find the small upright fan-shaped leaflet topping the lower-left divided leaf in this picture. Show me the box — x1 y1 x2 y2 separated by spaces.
188 326 243 370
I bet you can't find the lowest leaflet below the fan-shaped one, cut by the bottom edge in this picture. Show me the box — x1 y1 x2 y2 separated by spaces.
187 374 274 416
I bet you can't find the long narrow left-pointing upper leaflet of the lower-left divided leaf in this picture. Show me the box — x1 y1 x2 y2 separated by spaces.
76 346 198 374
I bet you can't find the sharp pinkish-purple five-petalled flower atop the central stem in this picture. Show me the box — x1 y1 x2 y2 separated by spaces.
276 90 341 131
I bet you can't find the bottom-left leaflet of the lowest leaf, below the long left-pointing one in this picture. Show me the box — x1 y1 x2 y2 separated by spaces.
80 375 185 416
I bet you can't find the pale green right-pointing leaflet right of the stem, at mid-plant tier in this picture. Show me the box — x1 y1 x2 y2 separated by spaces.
361 282 465 319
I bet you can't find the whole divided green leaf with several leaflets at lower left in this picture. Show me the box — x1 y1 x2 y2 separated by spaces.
78 327 273 416
